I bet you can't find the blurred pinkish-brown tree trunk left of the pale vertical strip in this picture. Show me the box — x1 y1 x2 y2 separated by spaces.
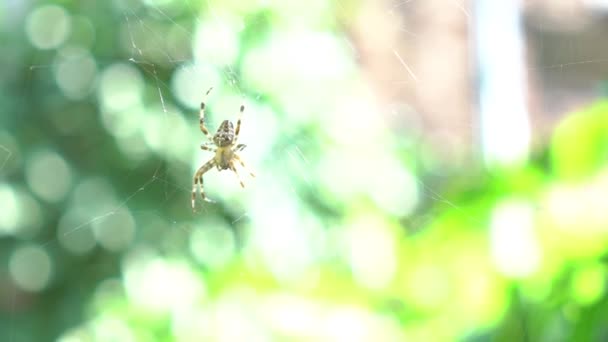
352 0 477 164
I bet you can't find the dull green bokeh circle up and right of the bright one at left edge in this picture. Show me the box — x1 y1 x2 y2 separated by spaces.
25 151 72 202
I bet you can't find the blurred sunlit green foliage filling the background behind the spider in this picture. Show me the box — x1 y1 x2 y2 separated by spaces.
0 0 608 342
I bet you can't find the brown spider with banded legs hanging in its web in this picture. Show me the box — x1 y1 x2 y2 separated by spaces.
192 87 255 211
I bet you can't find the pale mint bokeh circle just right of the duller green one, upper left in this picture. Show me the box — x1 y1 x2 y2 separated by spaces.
98 63 144 115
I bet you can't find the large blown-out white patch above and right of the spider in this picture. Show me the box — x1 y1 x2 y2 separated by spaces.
241 30 356 127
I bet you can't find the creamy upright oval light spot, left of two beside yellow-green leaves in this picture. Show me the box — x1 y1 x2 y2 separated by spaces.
346 216 396 289
